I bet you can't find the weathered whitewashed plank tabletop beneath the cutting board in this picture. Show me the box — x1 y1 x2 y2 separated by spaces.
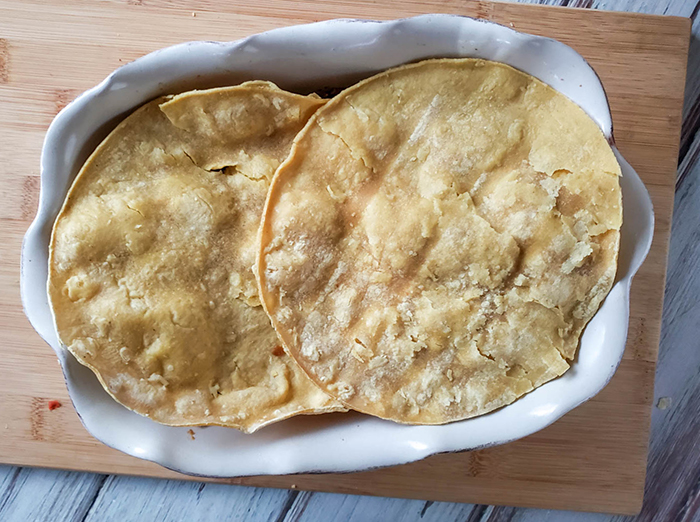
0 0 700 522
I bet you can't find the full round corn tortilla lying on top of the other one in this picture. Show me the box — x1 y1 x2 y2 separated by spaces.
257 59 622 424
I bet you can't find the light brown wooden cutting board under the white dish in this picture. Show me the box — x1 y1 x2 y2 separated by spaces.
0 0 690 513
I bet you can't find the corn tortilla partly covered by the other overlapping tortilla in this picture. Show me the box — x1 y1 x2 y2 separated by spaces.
48 82 343 432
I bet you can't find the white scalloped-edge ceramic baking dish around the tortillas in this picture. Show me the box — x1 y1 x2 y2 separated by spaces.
21 15 654 477
